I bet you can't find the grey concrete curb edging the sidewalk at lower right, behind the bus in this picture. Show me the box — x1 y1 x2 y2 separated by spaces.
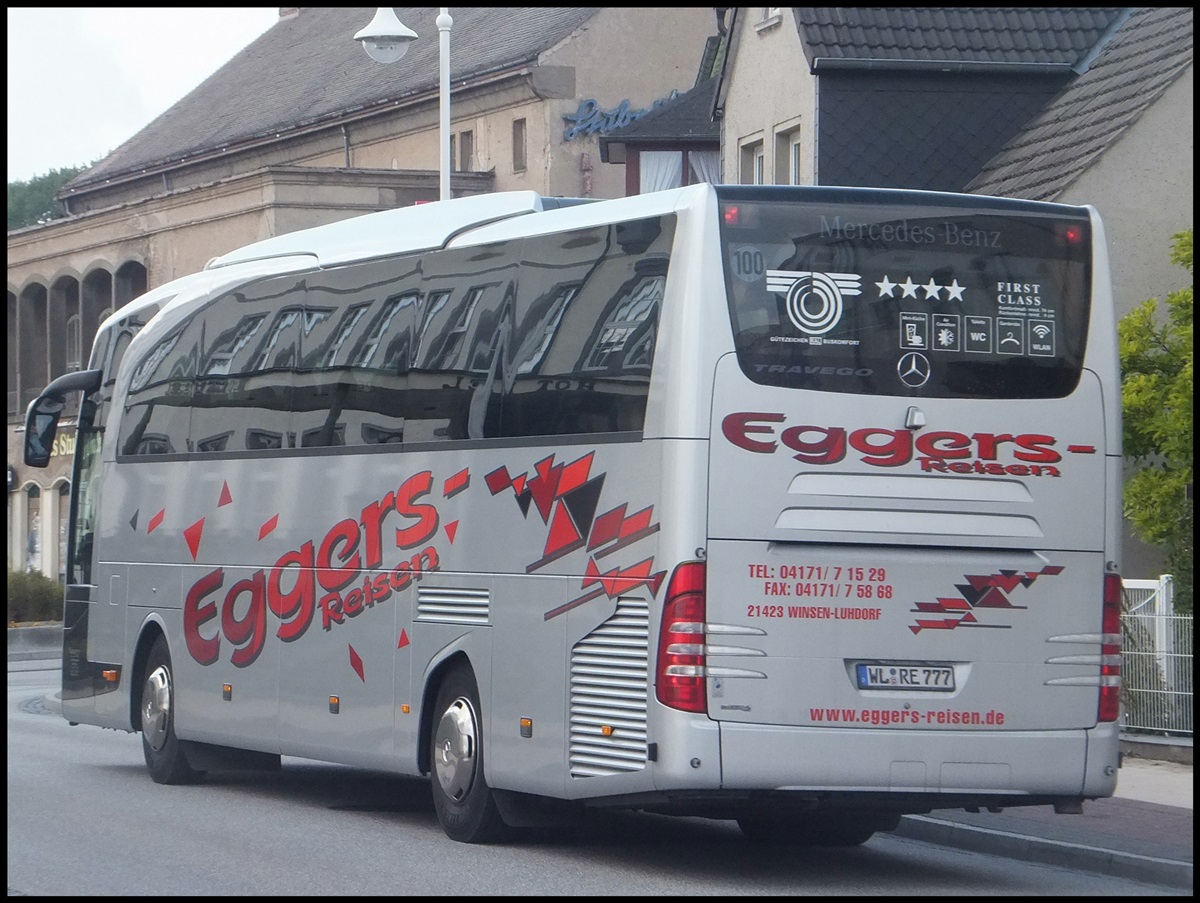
892 815 1193 890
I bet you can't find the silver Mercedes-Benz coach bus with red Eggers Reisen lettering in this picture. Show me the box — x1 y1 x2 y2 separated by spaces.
25 185 1121 844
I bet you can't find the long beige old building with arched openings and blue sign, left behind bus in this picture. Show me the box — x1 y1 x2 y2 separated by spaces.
8 7 715 574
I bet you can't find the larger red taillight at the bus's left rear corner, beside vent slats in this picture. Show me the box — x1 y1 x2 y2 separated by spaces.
655 561 708 714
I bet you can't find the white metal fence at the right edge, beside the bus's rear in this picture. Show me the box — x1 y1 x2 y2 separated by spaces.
1121 575 1193 737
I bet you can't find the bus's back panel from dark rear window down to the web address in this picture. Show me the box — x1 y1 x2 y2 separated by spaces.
708 192 1106 768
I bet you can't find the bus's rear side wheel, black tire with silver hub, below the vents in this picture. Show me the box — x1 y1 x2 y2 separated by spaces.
430 665 505 843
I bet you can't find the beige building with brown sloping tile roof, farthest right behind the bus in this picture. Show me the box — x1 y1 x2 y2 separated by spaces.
966 7 1194 321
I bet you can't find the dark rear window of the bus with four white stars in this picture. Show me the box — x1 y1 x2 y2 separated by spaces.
720 189 1091 397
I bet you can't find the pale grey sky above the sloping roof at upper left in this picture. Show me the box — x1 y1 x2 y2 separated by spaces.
8 6 274 181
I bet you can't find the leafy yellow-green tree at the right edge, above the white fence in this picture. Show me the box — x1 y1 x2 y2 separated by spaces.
1117 229 1193 611
